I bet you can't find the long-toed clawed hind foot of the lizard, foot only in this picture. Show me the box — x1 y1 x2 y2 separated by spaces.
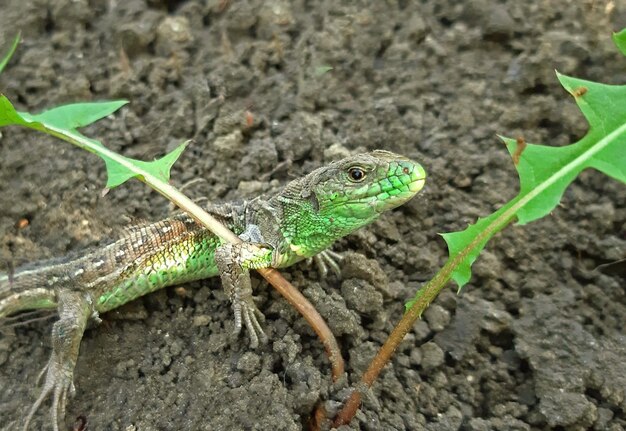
23 353 76 431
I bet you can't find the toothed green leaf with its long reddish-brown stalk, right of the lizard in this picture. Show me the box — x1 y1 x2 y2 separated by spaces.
333 29 626 426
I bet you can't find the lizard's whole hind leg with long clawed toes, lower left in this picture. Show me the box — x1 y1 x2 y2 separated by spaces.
24 290 93 431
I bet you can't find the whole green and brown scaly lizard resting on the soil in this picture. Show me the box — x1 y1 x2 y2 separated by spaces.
0 150 426 431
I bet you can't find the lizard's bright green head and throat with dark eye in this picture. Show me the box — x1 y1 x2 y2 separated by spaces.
280 150 426 257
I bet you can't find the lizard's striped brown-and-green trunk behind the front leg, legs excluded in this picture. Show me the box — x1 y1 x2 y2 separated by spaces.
0 204 241 318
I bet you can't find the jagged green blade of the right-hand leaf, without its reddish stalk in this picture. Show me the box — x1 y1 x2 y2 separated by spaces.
442 73 626 290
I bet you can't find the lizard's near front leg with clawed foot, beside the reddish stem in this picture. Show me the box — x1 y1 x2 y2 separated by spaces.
215 242 272 348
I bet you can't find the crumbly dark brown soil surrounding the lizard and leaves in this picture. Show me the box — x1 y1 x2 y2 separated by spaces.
0 0 626 431
